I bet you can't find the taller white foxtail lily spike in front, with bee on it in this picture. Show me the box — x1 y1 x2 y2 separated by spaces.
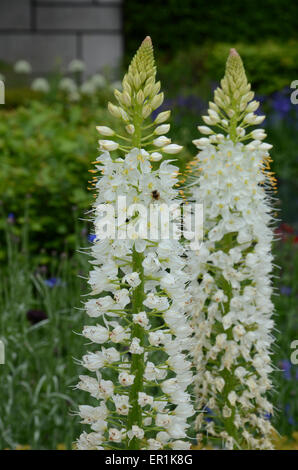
77 38 194 449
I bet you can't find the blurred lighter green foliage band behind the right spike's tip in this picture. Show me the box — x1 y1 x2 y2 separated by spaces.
157 41 298 94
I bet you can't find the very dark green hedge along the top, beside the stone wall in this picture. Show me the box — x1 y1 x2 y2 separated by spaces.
124 0 298 55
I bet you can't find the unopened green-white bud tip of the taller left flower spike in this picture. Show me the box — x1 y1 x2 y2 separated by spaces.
97 36 182 162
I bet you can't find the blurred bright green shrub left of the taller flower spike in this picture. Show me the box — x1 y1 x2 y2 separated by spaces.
0 101 121 257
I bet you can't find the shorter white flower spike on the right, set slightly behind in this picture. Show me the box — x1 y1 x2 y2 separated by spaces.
189 49 273 449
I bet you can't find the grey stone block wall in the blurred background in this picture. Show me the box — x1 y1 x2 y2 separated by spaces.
0 0 123 75
